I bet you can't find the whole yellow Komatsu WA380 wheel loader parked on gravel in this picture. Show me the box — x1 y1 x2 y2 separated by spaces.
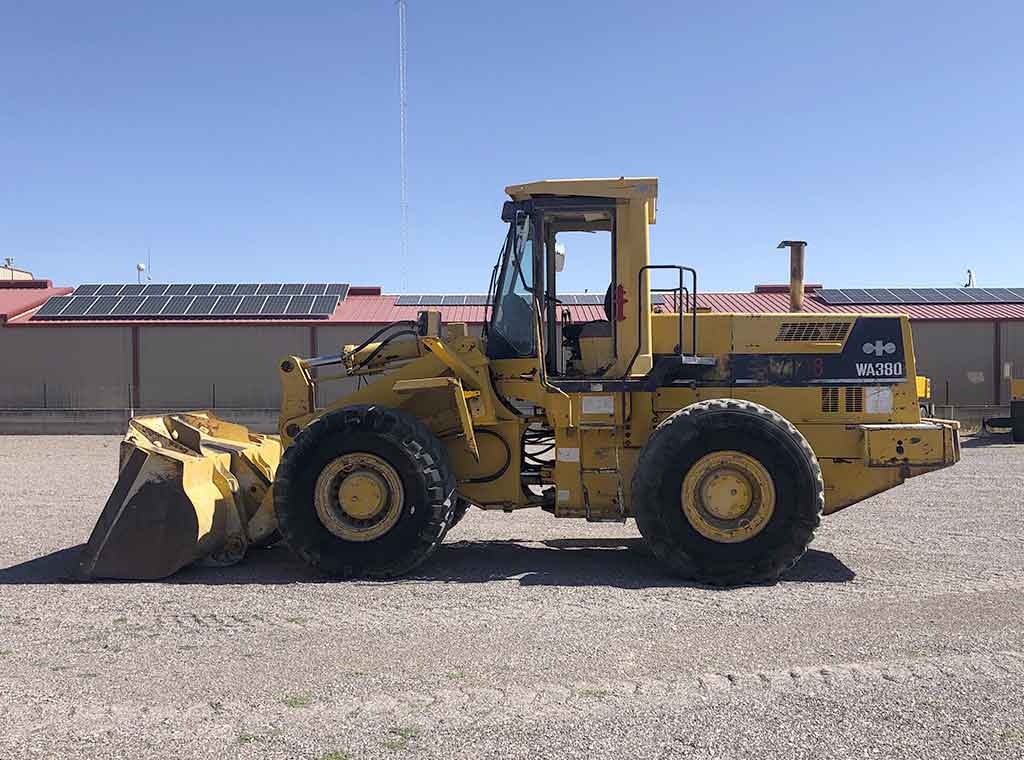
80 178 959 585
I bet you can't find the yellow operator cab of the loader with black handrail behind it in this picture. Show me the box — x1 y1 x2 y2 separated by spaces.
485 177 715 390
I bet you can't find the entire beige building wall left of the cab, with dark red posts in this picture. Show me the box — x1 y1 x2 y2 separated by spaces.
0 324 479 411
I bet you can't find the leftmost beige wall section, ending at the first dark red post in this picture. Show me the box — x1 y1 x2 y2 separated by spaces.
0 327 132 409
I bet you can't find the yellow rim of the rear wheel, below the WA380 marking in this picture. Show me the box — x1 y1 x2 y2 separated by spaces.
681 451 775 544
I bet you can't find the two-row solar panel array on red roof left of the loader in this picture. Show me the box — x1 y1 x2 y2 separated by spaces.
32 283 348 320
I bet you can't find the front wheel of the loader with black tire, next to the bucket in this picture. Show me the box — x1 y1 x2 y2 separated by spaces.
273 406 455 578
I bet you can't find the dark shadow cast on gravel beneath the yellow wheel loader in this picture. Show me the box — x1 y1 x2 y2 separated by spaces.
0 538 856 589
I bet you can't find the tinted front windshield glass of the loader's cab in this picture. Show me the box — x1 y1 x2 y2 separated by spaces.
487 212 537 358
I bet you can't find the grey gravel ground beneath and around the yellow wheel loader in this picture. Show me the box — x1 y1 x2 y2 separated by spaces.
0 436 1024 760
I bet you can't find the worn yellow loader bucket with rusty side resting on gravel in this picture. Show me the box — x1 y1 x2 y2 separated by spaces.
78 412 281 580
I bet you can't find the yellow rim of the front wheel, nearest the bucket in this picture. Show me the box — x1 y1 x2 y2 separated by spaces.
313 452 406 541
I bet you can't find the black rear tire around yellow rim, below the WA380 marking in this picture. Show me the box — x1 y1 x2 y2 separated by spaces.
632 399 824 586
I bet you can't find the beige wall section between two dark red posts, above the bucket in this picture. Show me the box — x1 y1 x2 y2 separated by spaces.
138 325 309 410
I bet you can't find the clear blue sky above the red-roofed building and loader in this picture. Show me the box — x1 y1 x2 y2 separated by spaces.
0 0 1024 292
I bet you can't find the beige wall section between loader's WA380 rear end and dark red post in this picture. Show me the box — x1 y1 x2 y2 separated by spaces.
910 321 995 406
